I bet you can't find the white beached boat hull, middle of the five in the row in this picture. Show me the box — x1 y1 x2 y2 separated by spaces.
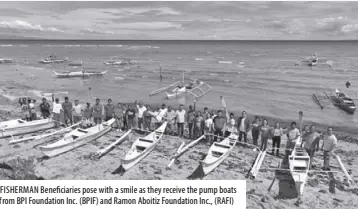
122 122 167 171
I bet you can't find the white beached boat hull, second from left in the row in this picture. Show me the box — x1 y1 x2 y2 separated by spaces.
40 119 115 157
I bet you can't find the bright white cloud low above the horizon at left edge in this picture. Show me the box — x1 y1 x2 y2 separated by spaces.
0 20 64 32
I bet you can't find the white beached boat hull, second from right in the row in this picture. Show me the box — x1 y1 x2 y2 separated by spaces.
200 134 238 176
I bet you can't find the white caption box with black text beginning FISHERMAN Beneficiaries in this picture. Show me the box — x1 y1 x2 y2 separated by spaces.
0 180 246 209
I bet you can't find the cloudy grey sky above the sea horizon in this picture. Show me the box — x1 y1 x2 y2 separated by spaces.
0 1 358 40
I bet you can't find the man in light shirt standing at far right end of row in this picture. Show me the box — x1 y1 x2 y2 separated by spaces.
321 127 337 171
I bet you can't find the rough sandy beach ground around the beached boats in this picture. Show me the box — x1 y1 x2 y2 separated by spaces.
0 79 358 209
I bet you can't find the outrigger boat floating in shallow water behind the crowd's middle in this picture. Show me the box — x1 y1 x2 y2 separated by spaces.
149 73 212 99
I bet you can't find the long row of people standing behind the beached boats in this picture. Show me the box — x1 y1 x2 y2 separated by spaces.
20 95 337 170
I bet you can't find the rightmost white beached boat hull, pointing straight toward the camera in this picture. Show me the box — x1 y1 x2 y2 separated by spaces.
288 137 310 198
